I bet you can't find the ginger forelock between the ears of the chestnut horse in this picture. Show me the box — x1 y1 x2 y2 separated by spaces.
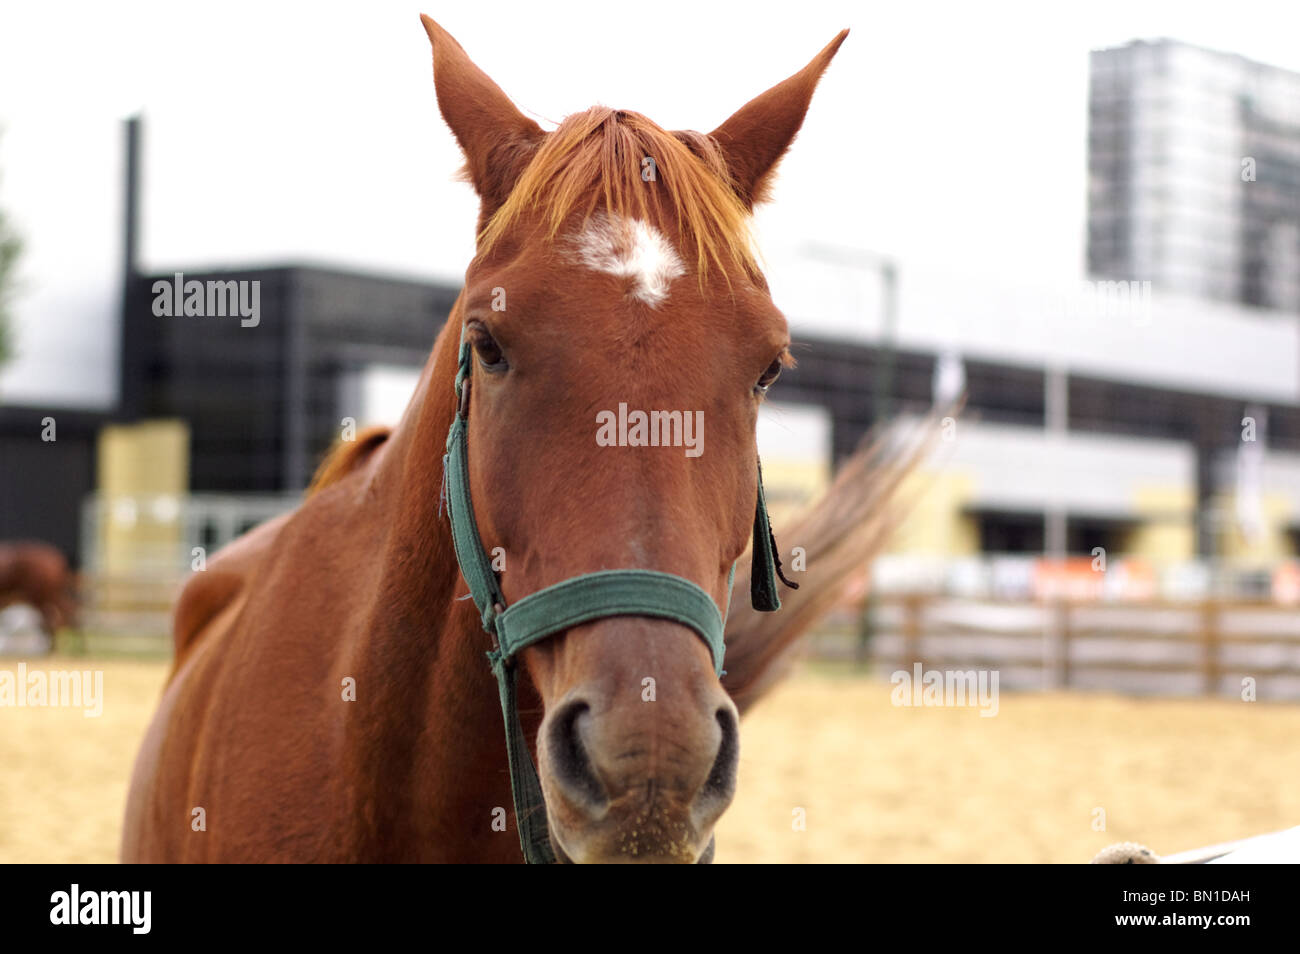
478 107 758 283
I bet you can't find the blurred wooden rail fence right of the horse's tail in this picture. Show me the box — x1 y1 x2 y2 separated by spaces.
811 594 1300 699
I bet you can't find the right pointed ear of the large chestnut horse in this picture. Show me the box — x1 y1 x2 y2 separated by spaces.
710 30 849 208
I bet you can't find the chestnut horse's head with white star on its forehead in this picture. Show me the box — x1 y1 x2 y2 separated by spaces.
423 17 846 863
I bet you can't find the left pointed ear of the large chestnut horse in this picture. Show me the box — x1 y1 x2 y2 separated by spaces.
420 14 546 222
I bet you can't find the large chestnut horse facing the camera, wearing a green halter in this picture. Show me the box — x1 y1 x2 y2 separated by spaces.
122 18 873 862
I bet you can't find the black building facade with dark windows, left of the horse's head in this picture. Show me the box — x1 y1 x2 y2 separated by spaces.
122 265 459 493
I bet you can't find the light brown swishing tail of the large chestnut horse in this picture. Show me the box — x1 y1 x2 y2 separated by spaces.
723 406 958 714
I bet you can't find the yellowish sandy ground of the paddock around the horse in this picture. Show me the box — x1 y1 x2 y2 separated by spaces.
0 659 1300 863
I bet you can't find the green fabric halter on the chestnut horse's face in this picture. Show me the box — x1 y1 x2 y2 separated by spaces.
442 328 797 864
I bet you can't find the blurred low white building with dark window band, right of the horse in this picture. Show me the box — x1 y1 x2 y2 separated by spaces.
772 254 1300 582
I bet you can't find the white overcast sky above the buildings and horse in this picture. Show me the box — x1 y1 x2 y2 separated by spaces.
0 0 1300 406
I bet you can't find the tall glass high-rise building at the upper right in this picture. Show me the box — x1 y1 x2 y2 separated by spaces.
1088 39 1300 312
